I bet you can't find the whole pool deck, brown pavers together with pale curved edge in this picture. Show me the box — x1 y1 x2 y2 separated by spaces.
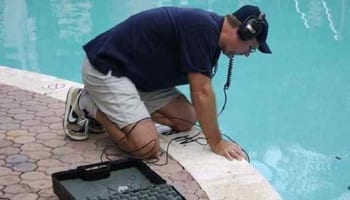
0 66 281 200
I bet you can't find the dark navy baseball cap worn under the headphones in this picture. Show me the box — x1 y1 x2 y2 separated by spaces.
232 5 272 53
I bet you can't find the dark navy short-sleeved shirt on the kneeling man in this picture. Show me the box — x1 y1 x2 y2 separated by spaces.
83 7 224 91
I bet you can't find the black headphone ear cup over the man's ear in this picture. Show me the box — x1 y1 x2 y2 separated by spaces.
238 13 266 41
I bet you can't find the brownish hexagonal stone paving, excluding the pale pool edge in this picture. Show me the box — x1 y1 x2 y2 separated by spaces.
0 84 208 200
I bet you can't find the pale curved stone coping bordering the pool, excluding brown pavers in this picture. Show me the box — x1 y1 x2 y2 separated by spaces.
0 66 281 200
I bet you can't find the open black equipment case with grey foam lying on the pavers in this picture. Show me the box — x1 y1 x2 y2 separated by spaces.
51 159 185 200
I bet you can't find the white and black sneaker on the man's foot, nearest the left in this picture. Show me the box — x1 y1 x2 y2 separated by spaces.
63 87 89 140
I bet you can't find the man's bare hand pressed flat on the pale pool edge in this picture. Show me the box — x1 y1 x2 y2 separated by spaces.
212 140 243 160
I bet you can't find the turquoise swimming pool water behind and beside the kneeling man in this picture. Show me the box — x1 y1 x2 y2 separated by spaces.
0 0 350 200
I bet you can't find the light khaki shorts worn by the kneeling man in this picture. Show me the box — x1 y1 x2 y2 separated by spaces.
82 59 181 128
